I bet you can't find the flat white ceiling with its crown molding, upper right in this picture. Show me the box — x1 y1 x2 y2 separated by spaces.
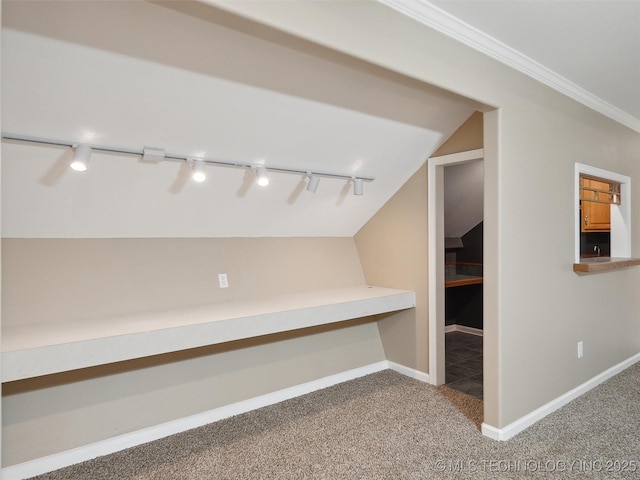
380 0 640 131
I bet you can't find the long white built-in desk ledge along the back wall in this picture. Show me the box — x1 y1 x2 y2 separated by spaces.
2 285 415 382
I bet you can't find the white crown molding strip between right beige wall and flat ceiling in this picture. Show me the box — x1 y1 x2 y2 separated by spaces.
378 0 640 132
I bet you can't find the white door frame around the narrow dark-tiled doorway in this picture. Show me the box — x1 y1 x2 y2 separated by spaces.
427 148 484 385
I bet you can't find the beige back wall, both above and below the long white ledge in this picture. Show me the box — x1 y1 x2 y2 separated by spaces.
2 238 385 466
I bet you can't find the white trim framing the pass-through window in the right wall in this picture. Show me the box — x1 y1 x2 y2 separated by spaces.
573 163 631 263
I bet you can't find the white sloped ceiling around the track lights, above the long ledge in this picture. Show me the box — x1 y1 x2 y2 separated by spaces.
2 1 474 237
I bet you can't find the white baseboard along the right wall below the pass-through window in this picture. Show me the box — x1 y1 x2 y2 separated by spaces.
482 353 640 441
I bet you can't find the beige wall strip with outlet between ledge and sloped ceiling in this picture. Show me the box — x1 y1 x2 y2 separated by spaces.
2 238 364 325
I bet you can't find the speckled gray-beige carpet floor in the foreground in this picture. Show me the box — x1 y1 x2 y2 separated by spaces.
31 363 640 480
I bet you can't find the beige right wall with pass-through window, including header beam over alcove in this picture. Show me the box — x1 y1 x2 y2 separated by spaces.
213 1 640 428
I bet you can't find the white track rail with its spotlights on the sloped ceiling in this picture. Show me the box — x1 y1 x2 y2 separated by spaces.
2 132 374 195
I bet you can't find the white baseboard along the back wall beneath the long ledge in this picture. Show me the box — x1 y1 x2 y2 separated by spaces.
0 360 384 480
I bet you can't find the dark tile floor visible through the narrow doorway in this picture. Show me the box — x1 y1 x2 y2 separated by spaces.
444 332 482 399
